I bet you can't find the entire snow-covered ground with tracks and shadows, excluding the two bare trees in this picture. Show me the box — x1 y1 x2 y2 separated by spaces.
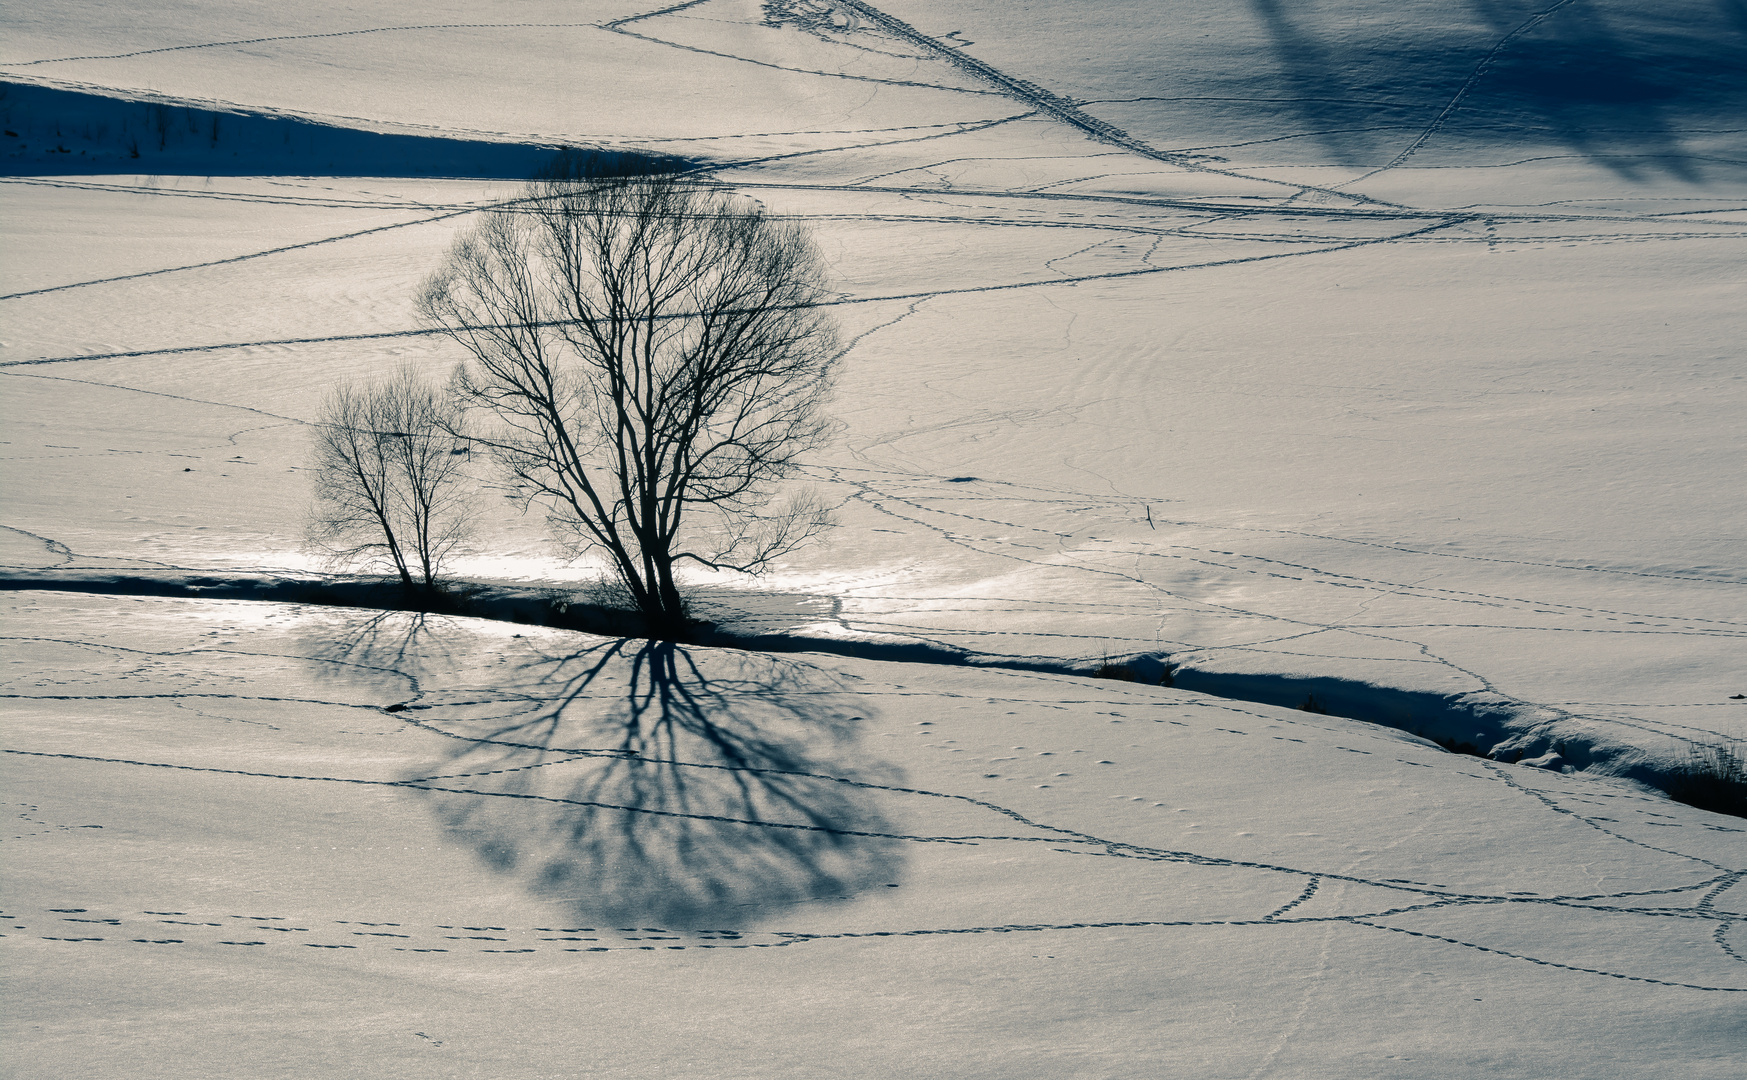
0 0 1747 1078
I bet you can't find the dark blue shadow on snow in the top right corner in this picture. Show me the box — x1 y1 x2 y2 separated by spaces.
1249 0 1747 182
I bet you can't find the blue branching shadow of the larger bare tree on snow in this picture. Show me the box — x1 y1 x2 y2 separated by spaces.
365 631 903 928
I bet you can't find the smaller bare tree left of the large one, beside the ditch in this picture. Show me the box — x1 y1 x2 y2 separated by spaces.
309 367 473 592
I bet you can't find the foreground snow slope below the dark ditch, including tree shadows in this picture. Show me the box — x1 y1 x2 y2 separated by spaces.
3 594 1742 1077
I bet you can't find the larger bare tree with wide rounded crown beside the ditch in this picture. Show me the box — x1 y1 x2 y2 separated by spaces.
418 177 837 638
